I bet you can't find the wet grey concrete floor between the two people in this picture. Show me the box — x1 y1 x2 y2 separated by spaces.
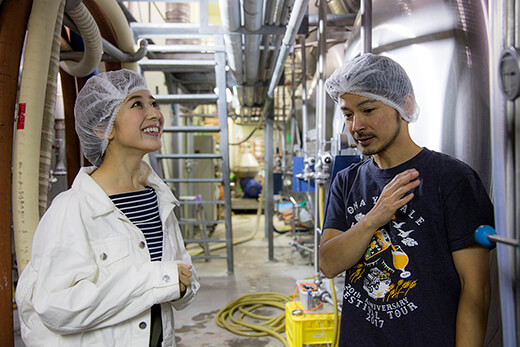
15 214 340 347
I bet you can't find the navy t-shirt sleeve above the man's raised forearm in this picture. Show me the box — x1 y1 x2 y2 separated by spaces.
323 171 348 231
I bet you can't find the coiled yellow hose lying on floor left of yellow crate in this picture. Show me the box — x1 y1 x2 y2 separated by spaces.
215 292 292 347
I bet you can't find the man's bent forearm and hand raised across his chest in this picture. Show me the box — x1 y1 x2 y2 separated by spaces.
319 169 420 278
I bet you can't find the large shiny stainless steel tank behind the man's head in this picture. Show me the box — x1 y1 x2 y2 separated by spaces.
333 0 491 189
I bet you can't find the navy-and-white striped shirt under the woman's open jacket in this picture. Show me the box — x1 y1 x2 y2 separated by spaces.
110 187 163 261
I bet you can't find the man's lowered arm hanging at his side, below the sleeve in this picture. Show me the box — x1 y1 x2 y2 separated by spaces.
452 245 491 347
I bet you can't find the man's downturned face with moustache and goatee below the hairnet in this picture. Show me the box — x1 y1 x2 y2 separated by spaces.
339 94 403 155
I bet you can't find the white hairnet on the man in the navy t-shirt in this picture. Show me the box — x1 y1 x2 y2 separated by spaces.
325 53 419 122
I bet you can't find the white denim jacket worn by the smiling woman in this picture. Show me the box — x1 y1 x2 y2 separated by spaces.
16 162 200 347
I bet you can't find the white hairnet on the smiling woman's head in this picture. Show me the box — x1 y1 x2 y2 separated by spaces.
74 69 148 166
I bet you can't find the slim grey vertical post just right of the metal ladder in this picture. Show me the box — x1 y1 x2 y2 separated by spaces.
262 100 274 261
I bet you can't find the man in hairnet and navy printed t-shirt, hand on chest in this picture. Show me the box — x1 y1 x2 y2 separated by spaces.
319 54 494 347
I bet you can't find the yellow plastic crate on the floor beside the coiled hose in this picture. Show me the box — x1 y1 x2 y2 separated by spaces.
285 301 340 347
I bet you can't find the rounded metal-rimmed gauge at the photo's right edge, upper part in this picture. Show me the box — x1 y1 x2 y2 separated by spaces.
499 46 520 101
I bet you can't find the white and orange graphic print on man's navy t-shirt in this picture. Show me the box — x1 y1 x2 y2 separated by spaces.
344 197 424 328
